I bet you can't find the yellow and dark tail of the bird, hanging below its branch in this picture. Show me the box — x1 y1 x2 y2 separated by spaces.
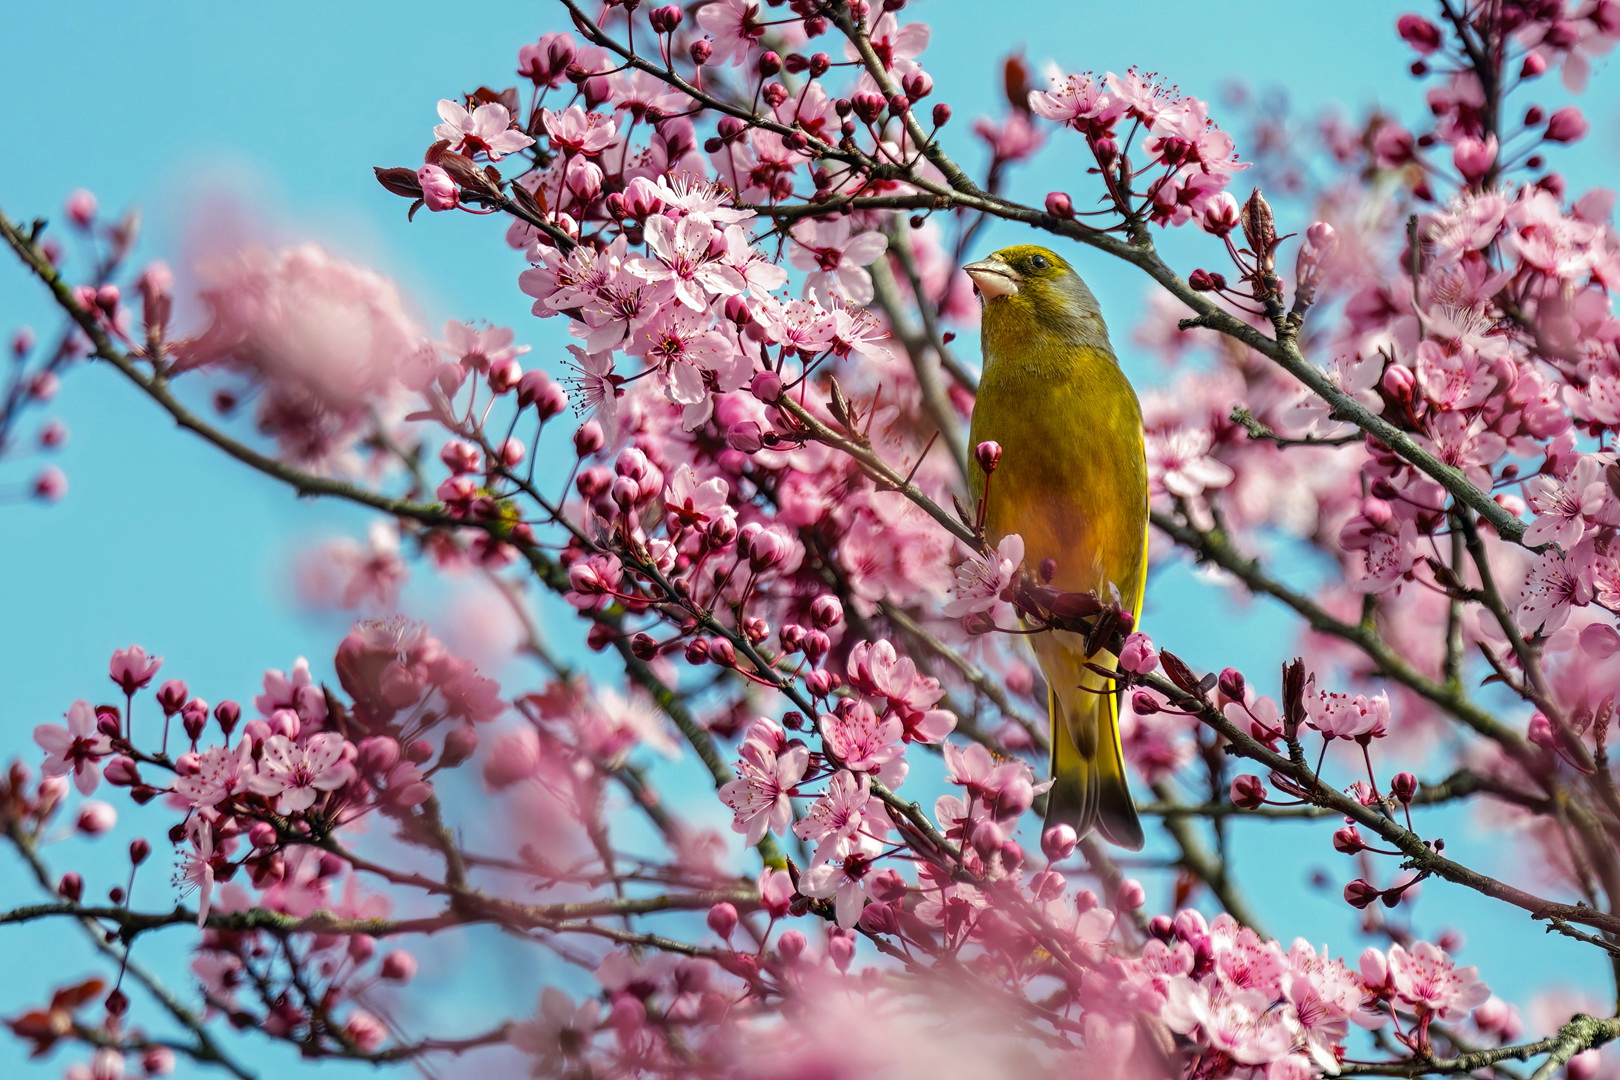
1043 653 1142 852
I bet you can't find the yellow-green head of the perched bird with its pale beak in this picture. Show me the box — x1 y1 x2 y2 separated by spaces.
962 244 1108 343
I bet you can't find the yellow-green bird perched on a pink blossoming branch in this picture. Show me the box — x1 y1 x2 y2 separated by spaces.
964 244 1147 852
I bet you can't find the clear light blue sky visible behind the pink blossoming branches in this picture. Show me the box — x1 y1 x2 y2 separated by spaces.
0 0 1620 1077
